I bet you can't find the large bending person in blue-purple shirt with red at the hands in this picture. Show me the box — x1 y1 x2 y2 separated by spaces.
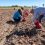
30 7 45 31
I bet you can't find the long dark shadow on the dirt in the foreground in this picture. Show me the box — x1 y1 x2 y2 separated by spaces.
6 28 38 39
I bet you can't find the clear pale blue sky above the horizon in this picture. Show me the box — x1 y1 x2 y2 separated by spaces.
0 0 45 7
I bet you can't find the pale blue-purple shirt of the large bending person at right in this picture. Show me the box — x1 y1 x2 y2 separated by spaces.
33 7 45 21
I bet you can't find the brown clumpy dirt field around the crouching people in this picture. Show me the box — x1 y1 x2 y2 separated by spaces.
0 9 45 45
